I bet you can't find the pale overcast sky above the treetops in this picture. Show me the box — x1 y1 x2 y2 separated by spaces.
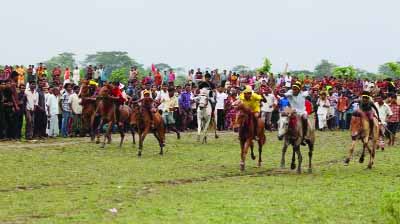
0 0 400 72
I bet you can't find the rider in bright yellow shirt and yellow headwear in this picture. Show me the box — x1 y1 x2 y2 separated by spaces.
239 86 266 136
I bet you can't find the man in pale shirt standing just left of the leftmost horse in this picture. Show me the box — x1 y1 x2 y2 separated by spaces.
68 86 82 136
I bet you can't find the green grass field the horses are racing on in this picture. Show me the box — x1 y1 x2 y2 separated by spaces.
0 132 400 223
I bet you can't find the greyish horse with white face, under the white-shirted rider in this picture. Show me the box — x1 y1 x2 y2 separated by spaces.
278 108 315 173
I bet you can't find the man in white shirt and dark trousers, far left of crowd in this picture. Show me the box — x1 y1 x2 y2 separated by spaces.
25 81 39 140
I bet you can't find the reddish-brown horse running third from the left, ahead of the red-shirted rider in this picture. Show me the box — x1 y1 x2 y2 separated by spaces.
130 99 165 157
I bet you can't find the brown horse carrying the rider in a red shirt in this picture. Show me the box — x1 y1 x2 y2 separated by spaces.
96 84 135 148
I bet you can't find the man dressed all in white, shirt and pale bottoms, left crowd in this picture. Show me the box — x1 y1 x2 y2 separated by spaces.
46 87 59 137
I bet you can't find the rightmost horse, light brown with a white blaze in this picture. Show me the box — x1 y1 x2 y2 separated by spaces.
344 111 379 169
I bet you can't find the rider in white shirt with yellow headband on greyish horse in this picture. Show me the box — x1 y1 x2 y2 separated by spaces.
284 81 308 145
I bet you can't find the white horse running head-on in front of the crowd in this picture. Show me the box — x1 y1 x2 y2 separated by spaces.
195 88 214 144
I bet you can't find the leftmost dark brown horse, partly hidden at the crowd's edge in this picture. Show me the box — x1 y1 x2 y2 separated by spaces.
78 80 96 141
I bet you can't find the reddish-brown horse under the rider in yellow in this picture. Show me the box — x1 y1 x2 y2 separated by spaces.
234 104 265 171
